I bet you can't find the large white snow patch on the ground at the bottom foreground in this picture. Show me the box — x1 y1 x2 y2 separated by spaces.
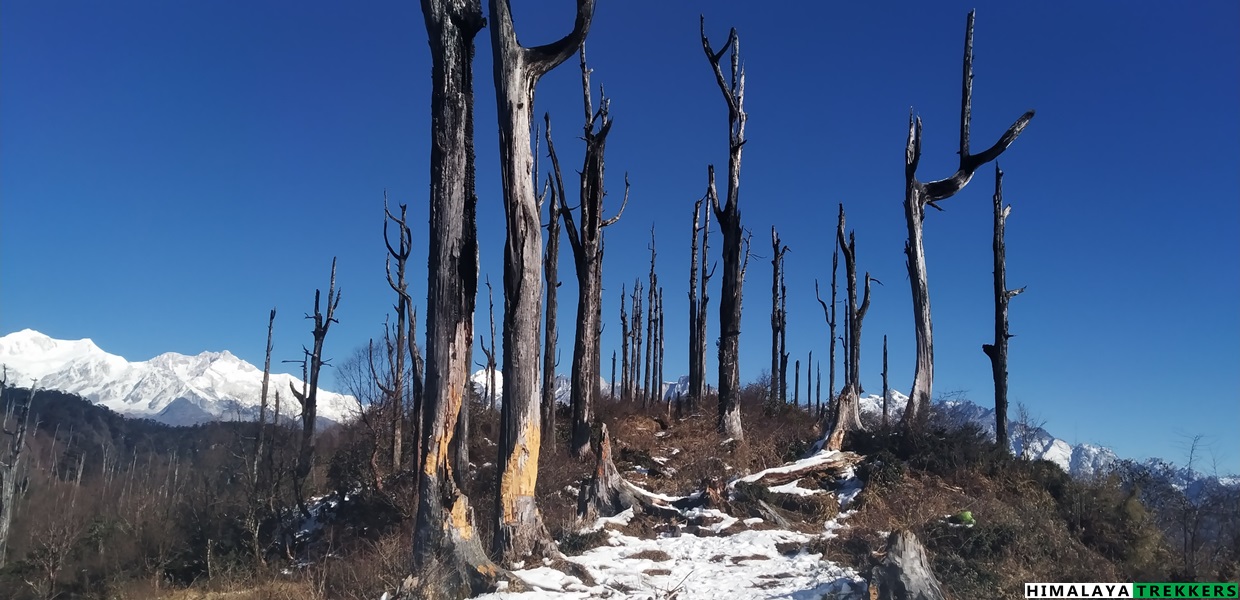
479 529 866 600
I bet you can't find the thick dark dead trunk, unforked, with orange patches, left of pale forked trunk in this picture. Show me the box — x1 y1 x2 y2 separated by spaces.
408 0 497 598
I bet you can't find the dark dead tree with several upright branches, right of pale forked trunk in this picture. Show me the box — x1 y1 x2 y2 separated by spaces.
546 52 629 457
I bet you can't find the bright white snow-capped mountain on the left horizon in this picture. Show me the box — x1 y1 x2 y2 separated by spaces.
0 330 357 425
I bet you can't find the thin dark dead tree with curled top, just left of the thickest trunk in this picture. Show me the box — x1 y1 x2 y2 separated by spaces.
383 191 413 472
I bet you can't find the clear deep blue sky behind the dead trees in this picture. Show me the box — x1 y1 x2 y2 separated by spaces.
0 0 1240 471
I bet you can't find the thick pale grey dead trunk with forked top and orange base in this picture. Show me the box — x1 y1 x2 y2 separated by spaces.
489 0 598 563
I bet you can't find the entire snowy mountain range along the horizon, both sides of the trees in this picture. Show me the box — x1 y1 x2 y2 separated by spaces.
0 330 1230 482
